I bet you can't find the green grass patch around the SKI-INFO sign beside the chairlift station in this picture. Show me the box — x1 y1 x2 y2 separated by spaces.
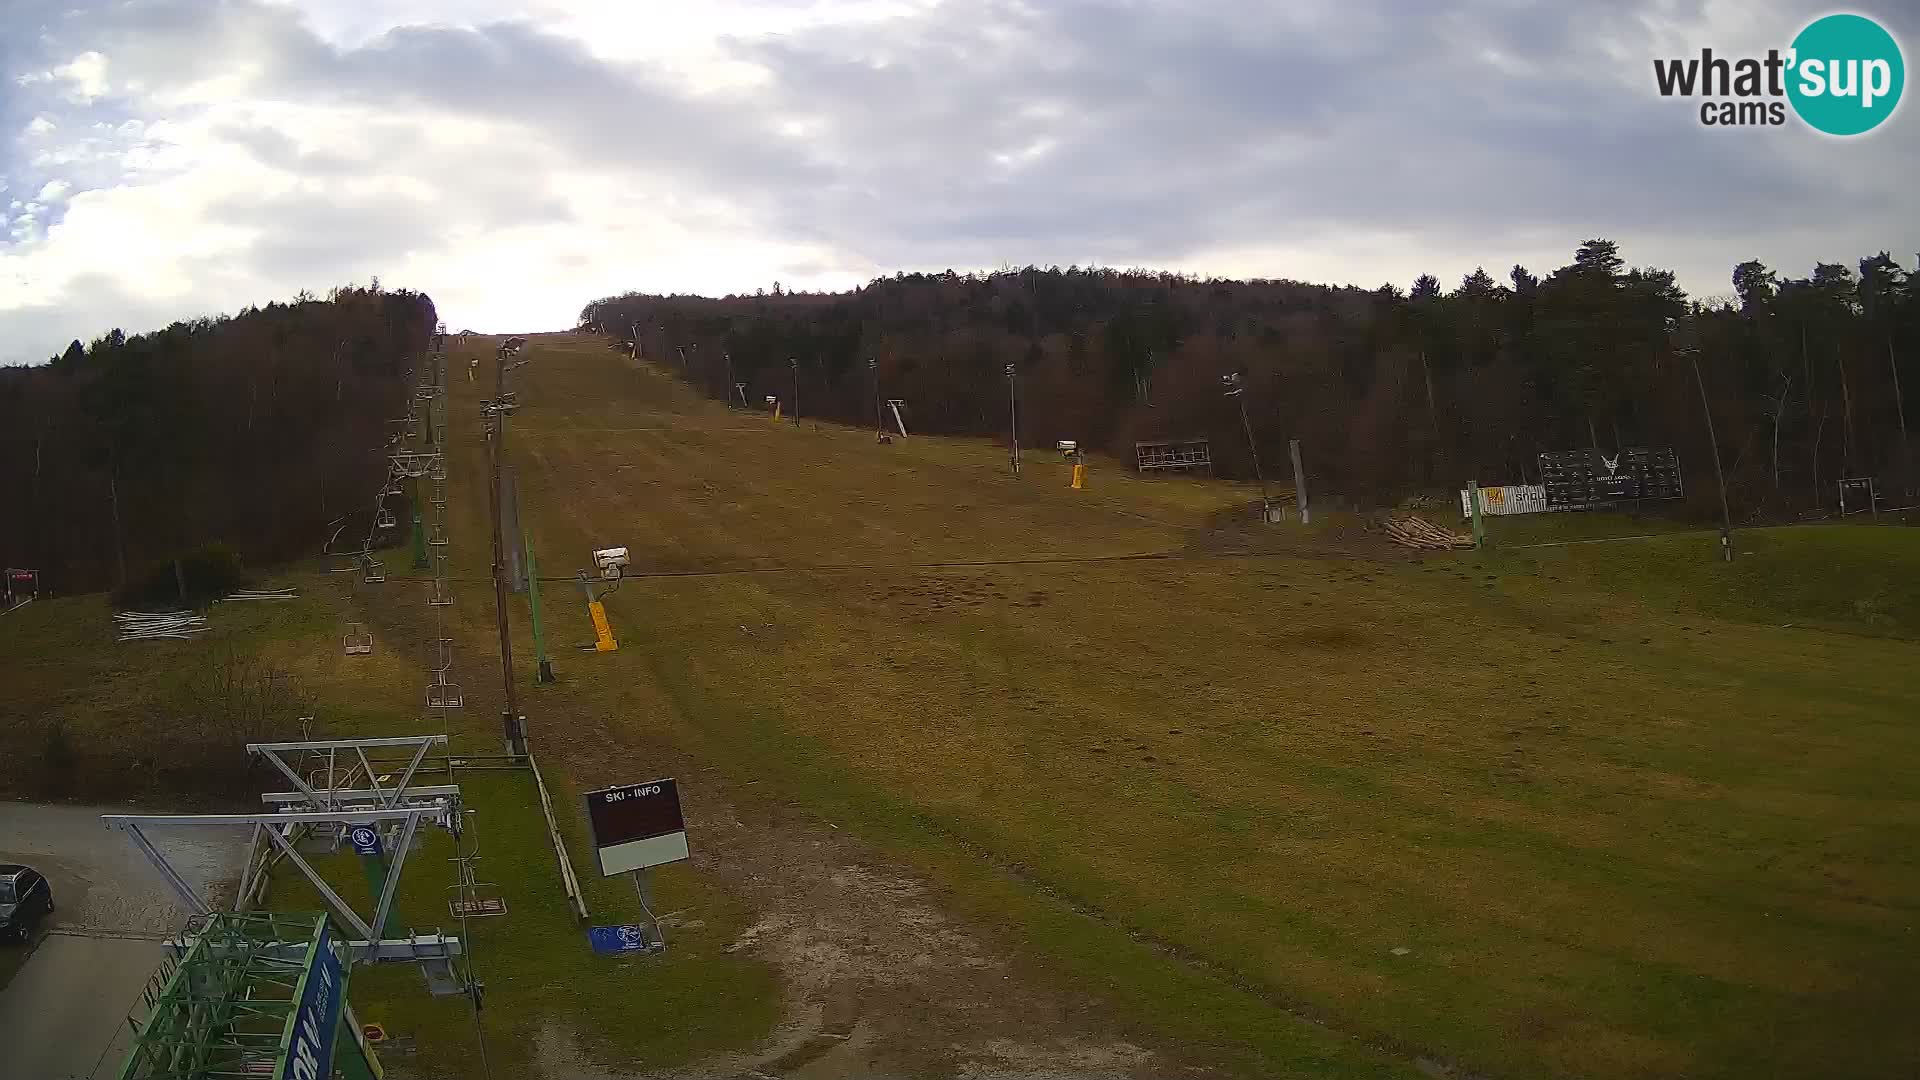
273 773 780 1076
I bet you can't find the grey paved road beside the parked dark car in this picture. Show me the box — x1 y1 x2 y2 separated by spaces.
0 801 246 1080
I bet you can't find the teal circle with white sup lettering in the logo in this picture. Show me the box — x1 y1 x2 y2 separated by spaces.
1788 15 1907 135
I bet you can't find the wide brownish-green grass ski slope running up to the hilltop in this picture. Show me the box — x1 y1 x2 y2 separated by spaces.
472 338 1920 1076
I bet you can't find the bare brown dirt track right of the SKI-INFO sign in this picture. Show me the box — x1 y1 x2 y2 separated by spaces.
518 687 1210 1080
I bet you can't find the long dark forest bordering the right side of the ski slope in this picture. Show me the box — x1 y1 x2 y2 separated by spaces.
580 238 1920 521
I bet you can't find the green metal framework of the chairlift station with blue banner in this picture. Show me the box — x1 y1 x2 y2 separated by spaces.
119 913 380 1080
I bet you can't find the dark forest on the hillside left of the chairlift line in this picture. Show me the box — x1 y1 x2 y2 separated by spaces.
0 281 436 594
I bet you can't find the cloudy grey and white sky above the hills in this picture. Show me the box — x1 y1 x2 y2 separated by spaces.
0 0 1920 363
